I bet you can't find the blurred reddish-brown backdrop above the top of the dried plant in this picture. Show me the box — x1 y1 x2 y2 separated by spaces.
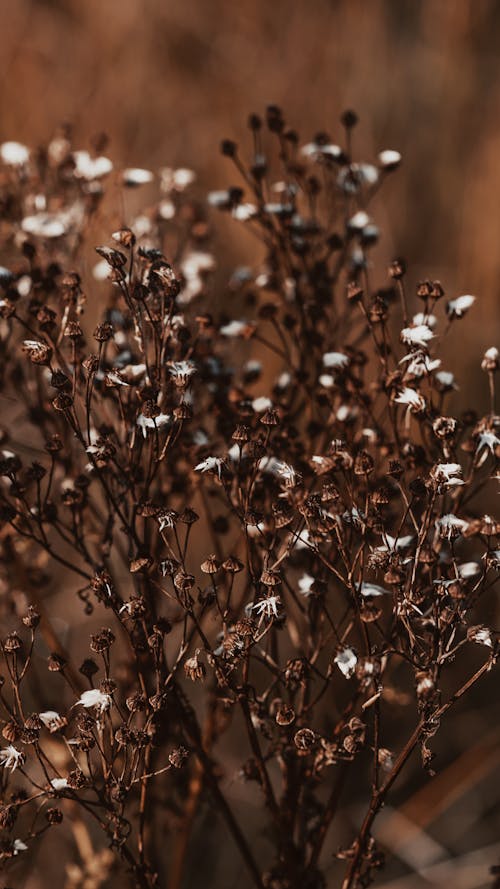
0 0 500 320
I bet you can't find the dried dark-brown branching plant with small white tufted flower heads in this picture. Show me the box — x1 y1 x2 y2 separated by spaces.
0 107 500 889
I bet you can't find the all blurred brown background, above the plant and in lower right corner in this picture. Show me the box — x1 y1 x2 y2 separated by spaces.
0 0 500 889
